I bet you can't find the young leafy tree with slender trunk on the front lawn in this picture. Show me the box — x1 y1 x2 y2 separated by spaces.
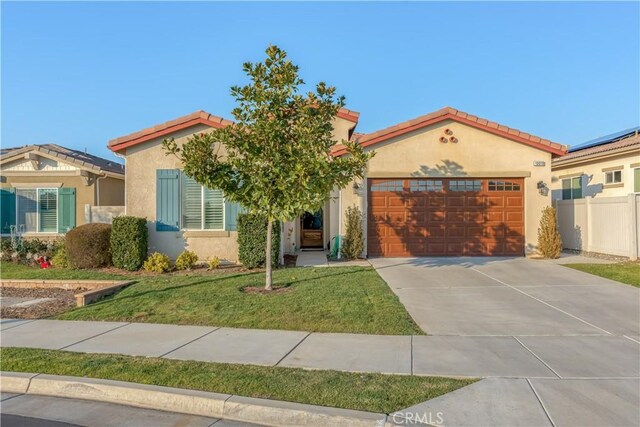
164 46 371 290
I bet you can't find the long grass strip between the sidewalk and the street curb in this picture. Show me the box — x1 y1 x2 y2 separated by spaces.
0 348 476 413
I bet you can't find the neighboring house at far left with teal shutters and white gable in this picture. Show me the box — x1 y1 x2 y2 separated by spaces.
0 144 124 238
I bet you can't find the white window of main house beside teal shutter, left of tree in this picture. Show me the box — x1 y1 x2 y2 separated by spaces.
181 175 224 230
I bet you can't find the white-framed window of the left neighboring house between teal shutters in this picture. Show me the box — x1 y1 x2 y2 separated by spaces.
16 188 58 233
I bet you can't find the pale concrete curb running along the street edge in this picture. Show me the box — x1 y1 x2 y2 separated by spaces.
0 372 397 427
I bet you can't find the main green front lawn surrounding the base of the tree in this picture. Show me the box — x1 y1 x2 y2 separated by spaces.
57 267 423 335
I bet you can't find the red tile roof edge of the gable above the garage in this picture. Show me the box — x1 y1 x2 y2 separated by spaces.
333 107 567 156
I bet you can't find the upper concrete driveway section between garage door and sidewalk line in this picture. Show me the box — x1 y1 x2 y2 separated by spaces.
370 258 640 340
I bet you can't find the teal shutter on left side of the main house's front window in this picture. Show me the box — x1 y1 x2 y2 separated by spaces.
156 169 180 231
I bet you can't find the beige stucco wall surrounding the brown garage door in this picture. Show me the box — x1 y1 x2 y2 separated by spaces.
332 120 551 253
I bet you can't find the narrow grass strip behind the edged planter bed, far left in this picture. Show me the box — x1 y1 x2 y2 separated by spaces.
0 262 131 280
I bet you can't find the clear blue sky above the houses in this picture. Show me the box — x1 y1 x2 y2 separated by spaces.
1 2 640 162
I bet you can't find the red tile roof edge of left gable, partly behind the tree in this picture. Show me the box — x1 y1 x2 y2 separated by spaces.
108 108 360 151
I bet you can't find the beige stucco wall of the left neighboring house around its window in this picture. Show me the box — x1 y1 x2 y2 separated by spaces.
0 172 95 234
